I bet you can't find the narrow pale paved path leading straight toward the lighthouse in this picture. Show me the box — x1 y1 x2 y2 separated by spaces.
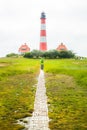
28 70 50 130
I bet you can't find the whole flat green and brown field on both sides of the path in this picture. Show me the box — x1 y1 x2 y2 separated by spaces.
0 58 87 130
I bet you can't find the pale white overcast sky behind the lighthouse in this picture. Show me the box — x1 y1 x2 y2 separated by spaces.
0 0 87 57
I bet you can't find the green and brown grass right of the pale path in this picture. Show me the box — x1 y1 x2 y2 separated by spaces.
45 60 87 130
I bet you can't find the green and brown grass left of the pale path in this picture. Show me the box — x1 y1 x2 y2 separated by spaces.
0 58 39 130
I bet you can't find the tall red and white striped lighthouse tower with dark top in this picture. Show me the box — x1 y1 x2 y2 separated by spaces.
40 12 47 51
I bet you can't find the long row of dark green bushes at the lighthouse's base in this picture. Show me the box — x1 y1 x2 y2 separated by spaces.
24 50 75 59
